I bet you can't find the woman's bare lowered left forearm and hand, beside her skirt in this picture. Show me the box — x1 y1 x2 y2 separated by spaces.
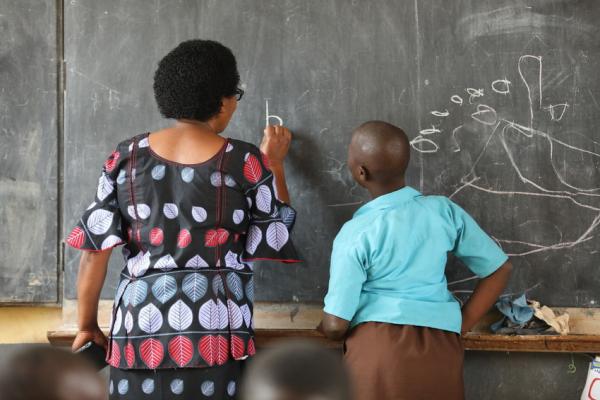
72 249 112 350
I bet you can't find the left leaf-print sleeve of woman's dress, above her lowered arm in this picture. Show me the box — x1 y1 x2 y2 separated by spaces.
66 148 126 251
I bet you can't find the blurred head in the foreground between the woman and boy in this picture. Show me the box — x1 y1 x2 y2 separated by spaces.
241 342 351 400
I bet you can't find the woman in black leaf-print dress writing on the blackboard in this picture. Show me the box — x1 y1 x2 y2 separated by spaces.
67 40 298 399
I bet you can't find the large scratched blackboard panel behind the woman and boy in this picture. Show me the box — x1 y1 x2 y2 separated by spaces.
65 0 600 306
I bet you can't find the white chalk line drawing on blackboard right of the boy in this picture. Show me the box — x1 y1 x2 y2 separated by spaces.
410 55 600 294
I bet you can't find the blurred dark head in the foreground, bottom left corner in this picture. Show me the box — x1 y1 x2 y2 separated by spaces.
0 347 107 400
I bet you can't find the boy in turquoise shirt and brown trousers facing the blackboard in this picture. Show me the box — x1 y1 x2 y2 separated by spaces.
319 121 512 400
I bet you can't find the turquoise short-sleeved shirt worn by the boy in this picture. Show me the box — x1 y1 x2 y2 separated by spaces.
325 187 508 333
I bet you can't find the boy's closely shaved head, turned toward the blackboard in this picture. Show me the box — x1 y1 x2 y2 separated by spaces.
348 121 410 193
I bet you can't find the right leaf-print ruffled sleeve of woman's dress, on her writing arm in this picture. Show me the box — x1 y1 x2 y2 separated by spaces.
243 146 300 263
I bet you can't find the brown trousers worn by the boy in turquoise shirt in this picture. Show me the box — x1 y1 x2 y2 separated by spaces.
344 322 464 400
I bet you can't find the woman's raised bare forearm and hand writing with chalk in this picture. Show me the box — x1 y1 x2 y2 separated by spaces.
260 125 292 204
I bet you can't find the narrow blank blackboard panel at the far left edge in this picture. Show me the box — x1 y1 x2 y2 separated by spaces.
0 0 59 303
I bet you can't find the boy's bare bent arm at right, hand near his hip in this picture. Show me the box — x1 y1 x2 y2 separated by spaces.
461 261 512 335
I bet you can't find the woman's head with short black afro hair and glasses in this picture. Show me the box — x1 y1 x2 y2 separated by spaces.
154 39 243 132
